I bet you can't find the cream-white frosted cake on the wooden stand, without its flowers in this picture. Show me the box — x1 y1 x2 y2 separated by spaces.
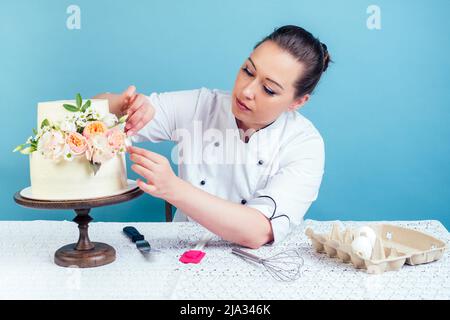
30 99 127 200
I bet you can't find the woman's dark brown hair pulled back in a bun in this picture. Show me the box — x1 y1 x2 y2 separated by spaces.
254 25 333 98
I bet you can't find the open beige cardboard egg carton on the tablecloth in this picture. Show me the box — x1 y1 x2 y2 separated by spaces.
305 223 447 274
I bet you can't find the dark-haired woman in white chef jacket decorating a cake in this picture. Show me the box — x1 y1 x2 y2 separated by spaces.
97 26 330 248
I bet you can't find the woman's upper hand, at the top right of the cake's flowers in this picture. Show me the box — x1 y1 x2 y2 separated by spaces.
122 86 155 136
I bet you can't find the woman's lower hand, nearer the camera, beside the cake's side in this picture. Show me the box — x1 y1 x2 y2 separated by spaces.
128 147 180 200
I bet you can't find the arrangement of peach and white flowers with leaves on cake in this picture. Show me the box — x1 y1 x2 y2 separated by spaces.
14 94 129 174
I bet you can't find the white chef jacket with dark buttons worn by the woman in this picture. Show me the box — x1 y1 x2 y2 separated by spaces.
132 87 325 244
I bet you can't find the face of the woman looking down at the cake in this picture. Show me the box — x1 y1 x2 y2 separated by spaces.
232 41 309 130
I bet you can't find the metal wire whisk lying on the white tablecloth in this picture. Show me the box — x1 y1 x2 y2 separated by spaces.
231 248 304 281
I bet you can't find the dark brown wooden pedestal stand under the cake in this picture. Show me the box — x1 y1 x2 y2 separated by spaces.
14 187 143 268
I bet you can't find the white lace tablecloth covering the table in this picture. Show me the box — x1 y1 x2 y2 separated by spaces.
0 220 450 299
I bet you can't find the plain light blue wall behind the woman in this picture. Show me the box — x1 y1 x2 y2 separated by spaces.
0 0 450 228
